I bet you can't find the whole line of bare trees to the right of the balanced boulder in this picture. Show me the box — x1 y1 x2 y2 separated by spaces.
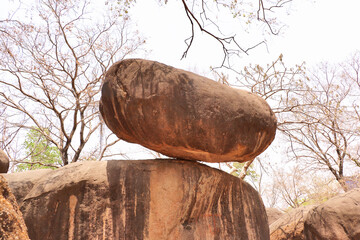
217 52 360 207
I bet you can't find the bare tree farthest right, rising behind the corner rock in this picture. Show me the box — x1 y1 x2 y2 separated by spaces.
282 61 360 191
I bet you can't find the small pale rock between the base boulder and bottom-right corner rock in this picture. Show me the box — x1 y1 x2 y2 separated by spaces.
270 206 314 240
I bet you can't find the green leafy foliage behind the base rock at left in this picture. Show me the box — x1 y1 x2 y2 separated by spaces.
16 129 62 172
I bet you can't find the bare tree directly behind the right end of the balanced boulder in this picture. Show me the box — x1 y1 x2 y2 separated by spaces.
214 55 305 179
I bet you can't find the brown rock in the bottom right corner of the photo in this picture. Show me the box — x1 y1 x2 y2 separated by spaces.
304 188 360 240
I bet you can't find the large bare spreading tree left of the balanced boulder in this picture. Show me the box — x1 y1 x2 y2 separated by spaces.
0 0 144 165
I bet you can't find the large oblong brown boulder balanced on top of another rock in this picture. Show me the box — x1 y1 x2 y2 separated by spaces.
100 59 276 162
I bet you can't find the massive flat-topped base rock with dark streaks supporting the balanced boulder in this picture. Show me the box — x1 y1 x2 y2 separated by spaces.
7 160 269 240
